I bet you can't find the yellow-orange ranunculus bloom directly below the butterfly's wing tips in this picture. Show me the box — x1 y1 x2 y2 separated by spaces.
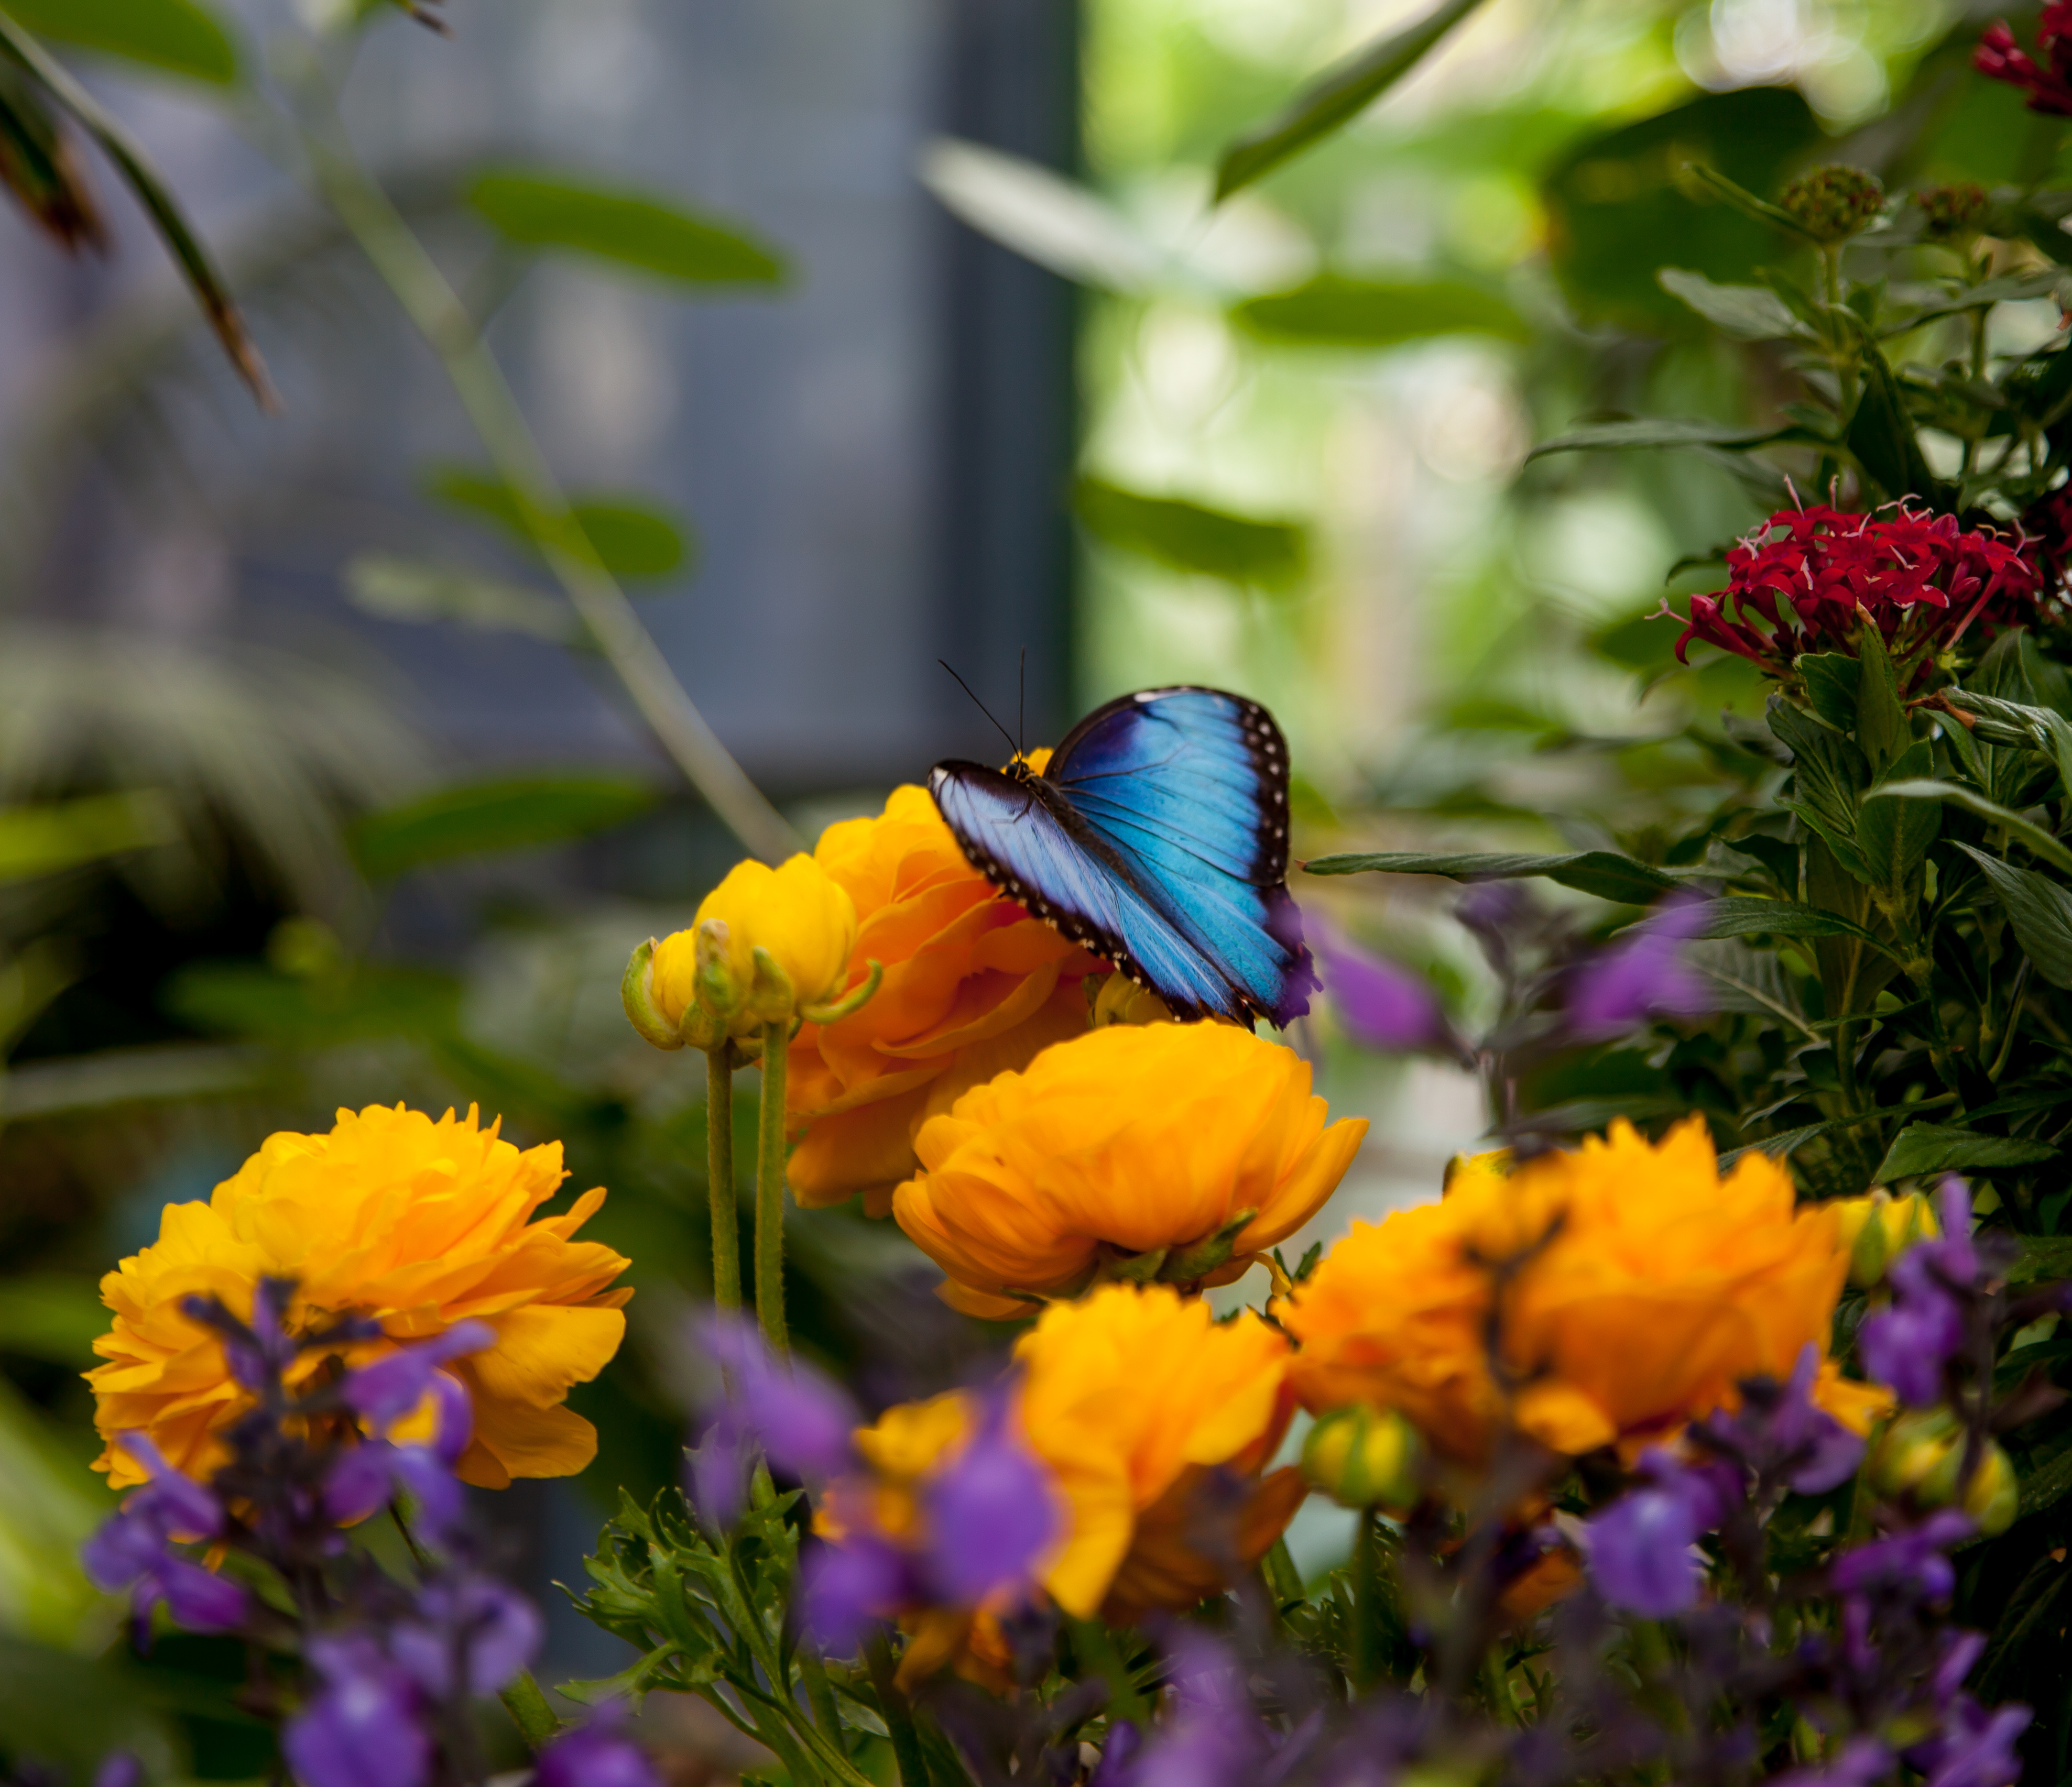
893 1023 1368 1317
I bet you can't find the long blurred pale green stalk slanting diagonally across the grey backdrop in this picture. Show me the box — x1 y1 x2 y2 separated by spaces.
288 74 798 861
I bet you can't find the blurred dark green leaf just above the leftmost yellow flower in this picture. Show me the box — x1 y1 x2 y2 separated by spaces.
166 961 460 1048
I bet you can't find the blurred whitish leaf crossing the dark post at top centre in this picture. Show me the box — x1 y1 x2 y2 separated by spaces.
920 137 1169 292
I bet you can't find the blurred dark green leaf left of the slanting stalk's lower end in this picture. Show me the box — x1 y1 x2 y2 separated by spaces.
352 774 657 880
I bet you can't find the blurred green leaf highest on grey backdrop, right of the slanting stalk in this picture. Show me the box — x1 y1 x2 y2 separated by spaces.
466 168 786 286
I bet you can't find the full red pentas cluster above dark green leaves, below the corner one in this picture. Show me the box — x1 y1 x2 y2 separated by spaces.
1666 503 2038 683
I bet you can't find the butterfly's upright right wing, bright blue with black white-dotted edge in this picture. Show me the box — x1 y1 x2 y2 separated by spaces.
1044 687 1316 1025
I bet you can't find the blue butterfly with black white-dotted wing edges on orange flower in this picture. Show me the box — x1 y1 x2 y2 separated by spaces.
928 687 1318 1025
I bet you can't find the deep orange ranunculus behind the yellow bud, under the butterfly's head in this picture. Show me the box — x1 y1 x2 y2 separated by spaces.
786 770 1103 1215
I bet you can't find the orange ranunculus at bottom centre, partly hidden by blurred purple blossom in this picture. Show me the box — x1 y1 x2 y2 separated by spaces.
816 1284 1307 1681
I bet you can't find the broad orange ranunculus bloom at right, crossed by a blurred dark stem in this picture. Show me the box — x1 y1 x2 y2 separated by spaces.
1279 1116 1877 1464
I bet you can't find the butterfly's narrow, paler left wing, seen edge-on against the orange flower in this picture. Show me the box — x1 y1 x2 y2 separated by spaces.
928 762 1249 1019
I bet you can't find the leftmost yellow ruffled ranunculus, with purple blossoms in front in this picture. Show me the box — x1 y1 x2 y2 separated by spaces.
87 1104 632 1489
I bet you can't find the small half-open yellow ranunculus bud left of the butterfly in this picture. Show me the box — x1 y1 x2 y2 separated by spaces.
653 853 856 1037
